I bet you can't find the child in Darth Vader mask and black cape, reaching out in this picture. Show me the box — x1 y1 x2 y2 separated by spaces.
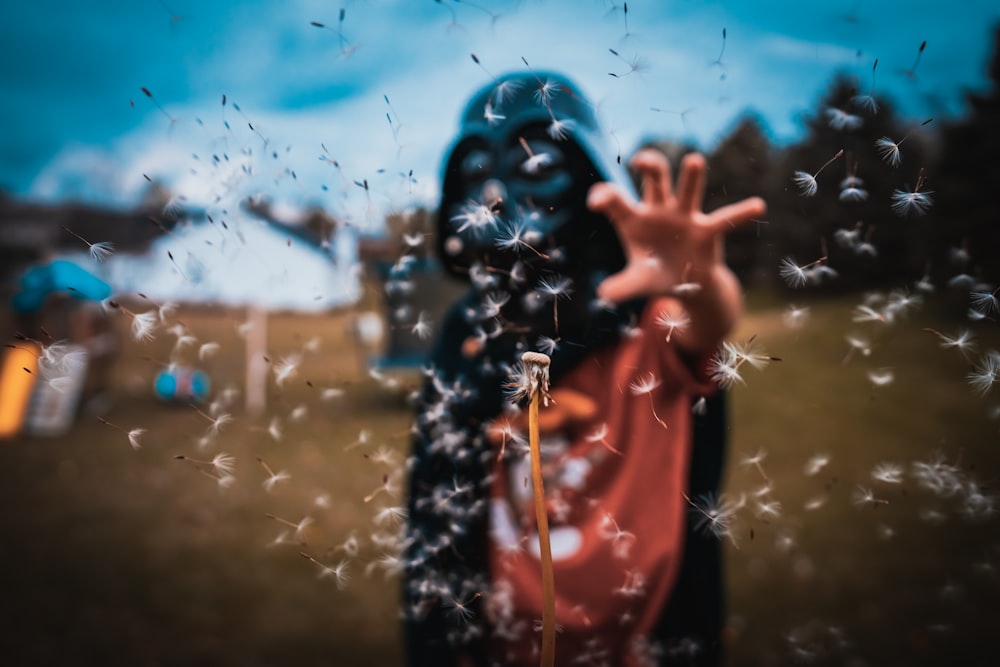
403 72 765 665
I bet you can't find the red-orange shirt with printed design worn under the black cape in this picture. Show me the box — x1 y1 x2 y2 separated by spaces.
488 303 716 665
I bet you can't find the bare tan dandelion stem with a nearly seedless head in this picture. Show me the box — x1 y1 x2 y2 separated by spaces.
521 352 556 667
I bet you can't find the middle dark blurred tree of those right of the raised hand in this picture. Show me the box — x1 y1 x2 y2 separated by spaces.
766 75 929 290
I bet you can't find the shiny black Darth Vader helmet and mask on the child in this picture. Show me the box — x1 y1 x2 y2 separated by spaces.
438 73 631 334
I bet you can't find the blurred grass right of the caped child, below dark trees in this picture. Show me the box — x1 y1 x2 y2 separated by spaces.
727 299 1000 665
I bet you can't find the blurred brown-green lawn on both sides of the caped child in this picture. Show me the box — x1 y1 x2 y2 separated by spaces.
0 295 1000 667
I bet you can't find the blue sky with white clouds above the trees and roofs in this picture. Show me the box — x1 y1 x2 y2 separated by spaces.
0 0 1000 227
